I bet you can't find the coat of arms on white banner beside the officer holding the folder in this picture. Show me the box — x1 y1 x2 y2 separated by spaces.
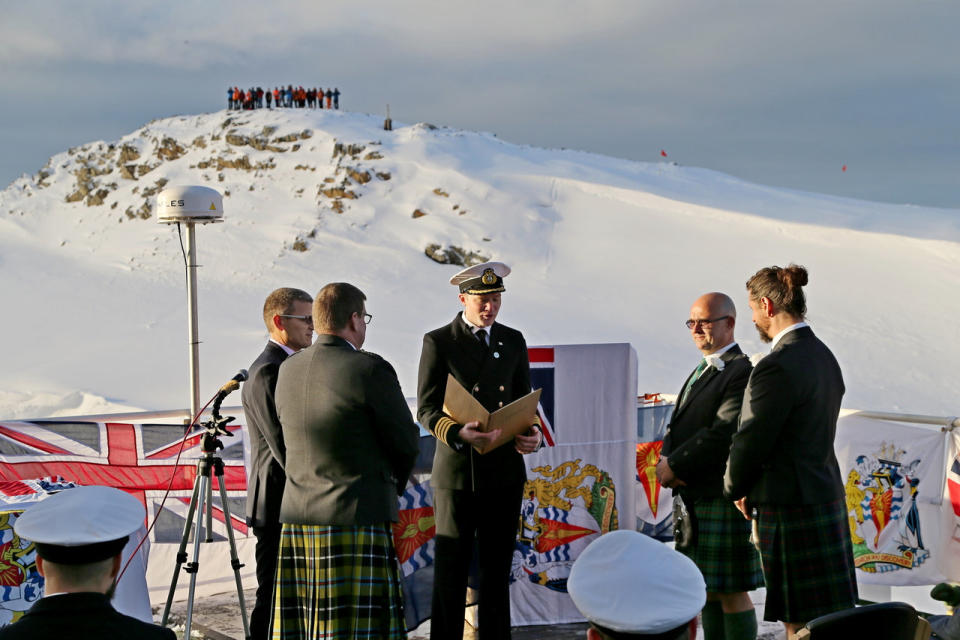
510 459 619 593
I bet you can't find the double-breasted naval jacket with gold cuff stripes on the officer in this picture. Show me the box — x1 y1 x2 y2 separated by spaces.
417 313 530 489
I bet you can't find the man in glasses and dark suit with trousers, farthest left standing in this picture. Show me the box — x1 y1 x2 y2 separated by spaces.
241 287 313 640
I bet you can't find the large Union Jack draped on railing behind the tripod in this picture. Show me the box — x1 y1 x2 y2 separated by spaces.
0 421 248 542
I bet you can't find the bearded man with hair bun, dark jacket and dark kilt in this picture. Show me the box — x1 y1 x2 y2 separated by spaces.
724 265 857 638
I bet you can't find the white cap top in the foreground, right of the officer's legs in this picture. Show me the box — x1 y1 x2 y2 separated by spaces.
567 529 707 635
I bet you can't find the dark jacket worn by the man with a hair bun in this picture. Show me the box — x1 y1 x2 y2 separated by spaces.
724 327 845 505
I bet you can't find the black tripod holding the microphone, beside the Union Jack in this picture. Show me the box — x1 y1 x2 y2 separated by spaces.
160 404 250 639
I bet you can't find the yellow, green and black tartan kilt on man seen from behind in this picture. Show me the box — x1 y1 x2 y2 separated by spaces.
273 523 407 640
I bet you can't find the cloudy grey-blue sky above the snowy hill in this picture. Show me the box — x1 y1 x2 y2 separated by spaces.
0 0 960 208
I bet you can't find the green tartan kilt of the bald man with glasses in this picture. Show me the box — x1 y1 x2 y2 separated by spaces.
681 498 763 593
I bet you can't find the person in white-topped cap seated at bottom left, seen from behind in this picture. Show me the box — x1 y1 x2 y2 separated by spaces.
0 486 177 640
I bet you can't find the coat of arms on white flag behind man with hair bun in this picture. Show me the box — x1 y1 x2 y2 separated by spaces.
845 443 930 573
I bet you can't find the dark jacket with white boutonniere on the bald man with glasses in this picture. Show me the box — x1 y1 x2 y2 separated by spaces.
662 345 752 499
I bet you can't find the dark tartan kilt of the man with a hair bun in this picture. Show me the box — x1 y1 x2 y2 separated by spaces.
757 499 857 624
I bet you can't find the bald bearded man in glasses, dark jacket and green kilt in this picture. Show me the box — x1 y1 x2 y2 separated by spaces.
657 293 763 640
